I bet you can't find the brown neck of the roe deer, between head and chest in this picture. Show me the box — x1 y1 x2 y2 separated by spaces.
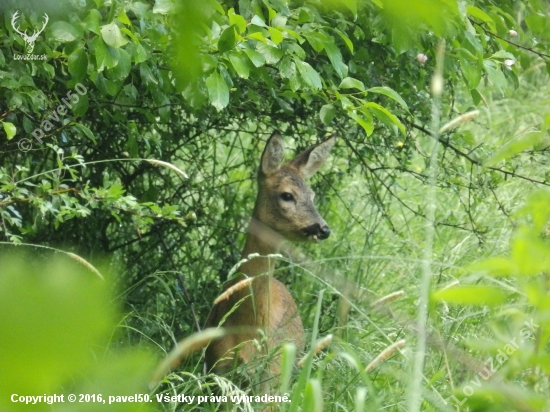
239 216 283 276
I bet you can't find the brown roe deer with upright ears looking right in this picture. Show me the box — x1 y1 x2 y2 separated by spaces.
206 132 335 389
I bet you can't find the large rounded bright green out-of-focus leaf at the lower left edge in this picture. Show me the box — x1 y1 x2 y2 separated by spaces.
0 252 114 396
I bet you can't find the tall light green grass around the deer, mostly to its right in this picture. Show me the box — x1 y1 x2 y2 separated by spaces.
131 62 550 412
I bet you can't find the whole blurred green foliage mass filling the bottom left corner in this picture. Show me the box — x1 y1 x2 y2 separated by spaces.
0 252 153 411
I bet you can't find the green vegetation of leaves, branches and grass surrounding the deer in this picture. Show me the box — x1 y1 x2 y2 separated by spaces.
0 0 550 411
